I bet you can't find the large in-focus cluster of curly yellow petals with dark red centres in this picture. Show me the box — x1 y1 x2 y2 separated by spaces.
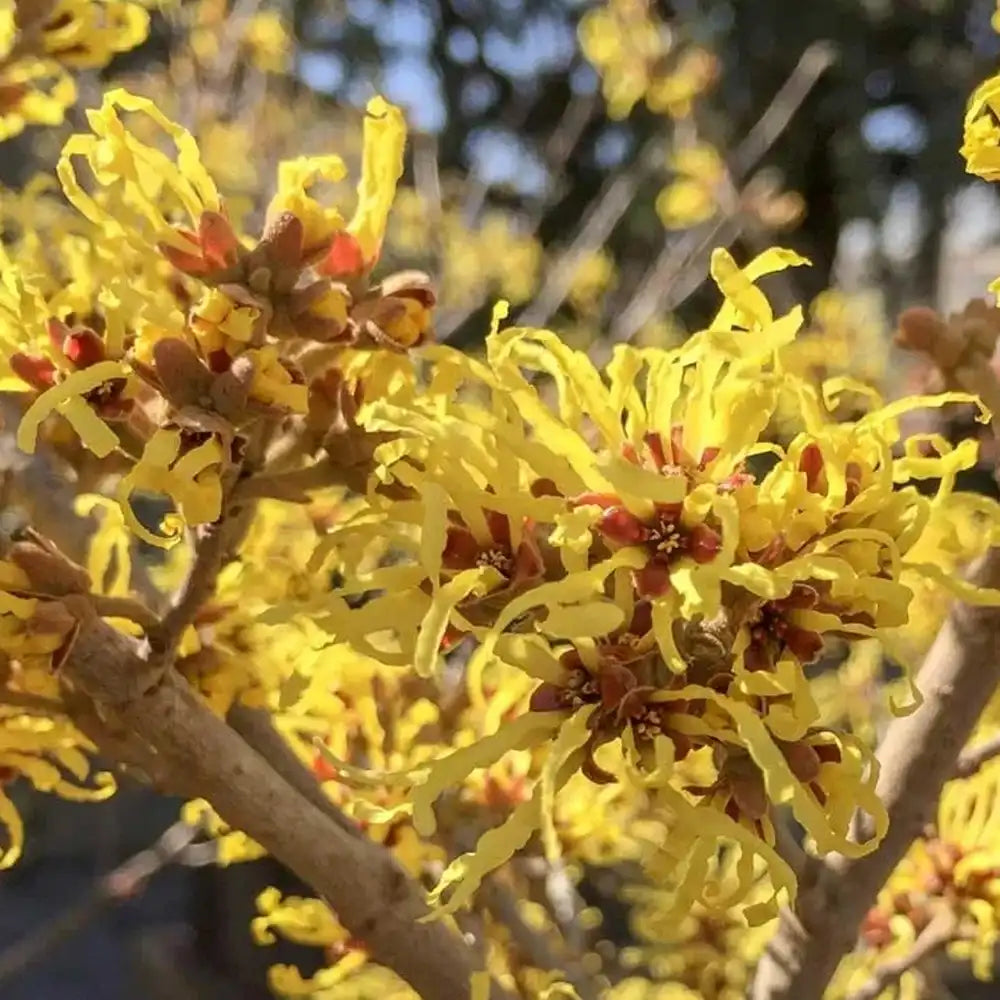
254 240 996 920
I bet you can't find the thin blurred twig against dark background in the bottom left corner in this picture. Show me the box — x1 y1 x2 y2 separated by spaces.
0 823 200 987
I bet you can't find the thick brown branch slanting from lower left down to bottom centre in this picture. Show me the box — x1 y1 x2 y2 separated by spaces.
63 615 510 1000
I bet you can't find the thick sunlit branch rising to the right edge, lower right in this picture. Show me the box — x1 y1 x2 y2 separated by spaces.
751 549 1000 1000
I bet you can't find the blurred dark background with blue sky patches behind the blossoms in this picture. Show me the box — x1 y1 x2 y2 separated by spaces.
0 0 1000 1000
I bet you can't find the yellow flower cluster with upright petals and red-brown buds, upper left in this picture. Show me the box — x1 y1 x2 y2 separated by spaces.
5 91 433 546
